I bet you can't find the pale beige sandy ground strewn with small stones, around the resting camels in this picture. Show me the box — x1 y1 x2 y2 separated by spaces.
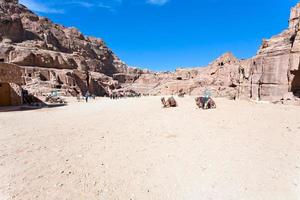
0 97 300 200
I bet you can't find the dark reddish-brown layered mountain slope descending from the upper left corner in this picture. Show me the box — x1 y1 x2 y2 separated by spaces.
0 0 128 95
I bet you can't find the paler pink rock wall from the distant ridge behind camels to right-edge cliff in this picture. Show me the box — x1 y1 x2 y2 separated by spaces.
128 3 300 102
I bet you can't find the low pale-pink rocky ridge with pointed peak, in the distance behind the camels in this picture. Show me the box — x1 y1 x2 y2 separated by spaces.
127 53 244 96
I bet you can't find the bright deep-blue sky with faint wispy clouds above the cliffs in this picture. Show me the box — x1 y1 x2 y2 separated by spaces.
20 0 298 70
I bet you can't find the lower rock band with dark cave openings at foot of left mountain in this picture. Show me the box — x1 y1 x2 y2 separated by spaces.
23 67 120 96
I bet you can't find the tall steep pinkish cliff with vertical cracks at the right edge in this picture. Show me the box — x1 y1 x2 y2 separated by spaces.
238 3 300 101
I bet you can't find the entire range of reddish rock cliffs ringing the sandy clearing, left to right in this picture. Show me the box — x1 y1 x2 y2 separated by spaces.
0 0 300 101
